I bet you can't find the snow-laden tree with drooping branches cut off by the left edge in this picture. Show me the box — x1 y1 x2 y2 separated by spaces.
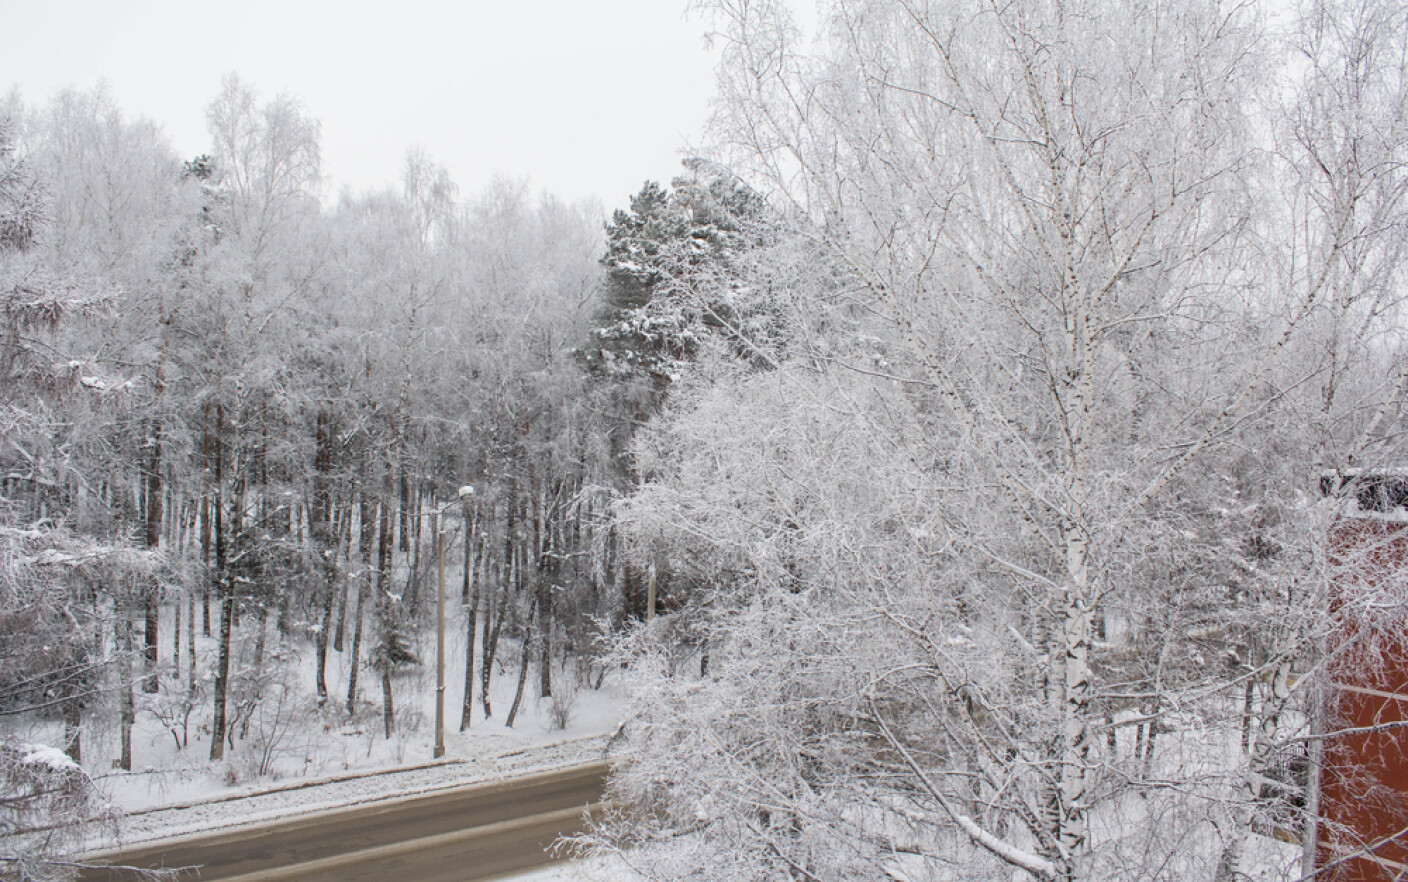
0 128 156 881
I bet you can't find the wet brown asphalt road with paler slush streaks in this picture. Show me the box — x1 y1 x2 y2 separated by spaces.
79 764 607 882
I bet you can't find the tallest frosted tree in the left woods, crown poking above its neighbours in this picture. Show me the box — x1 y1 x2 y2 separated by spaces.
197 75 320 759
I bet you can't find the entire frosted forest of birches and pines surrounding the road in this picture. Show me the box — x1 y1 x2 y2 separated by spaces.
0 0 1408 882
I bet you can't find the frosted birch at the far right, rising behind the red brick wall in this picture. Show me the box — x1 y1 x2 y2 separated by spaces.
1224 0 1408 878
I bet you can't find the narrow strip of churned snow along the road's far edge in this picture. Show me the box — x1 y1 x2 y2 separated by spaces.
87 735 607 851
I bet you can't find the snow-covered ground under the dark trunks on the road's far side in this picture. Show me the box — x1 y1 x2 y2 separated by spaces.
6 597 621 847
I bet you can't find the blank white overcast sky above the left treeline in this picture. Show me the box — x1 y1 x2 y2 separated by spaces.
0 0 717 210
